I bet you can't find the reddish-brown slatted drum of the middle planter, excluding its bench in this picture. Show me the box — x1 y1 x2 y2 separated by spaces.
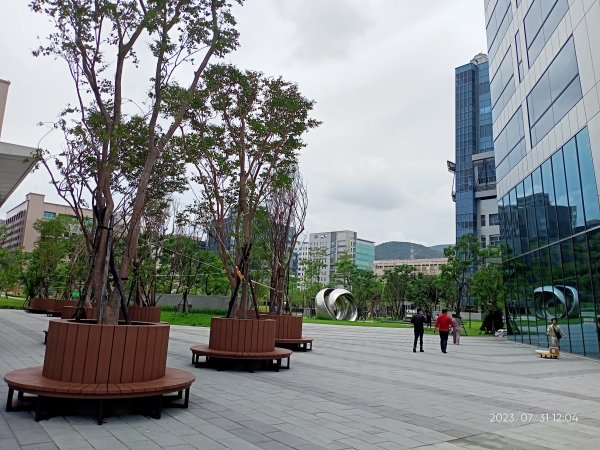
208 317 276 353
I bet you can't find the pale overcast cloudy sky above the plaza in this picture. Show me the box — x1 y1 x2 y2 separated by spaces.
0 0 486 245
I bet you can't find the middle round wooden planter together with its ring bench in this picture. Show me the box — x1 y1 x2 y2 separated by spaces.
190 317 292 371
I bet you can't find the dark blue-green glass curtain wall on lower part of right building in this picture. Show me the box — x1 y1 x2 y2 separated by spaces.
499 128 600 357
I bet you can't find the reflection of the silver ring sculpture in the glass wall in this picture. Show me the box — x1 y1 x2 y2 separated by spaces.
533 285 579 319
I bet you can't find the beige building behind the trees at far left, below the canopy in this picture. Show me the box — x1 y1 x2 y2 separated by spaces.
3 193 93 252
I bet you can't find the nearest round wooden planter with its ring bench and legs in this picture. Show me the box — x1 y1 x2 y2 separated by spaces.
4 320 196 424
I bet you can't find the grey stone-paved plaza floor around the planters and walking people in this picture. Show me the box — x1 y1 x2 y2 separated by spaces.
0 310 600 450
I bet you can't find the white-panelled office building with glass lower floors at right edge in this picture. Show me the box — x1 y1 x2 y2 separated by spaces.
484 0 600 358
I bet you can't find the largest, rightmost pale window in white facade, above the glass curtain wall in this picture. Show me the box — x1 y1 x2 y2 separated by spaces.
527 36 583 147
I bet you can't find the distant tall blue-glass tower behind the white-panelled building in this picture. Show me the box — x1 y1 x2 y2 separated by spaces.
453 53 500 247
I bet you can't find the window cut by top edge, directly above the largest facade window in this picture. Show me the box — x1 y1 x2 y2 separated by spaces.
523 0 569 67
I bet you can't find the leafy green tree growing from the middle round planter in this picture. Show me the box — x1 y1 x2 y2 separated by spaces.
182 65 319 314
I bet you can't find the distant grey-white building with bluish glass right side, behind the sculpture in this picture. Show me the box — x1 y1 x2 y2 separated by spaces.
296 230 375 285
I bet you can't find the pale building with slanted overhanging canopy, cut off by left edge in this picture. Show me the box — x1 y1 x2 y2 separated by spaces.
0 79 36 207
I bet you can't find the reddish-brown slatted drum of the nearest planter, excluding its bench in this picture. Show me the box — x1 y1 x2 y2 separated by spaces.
42 320 169 384
